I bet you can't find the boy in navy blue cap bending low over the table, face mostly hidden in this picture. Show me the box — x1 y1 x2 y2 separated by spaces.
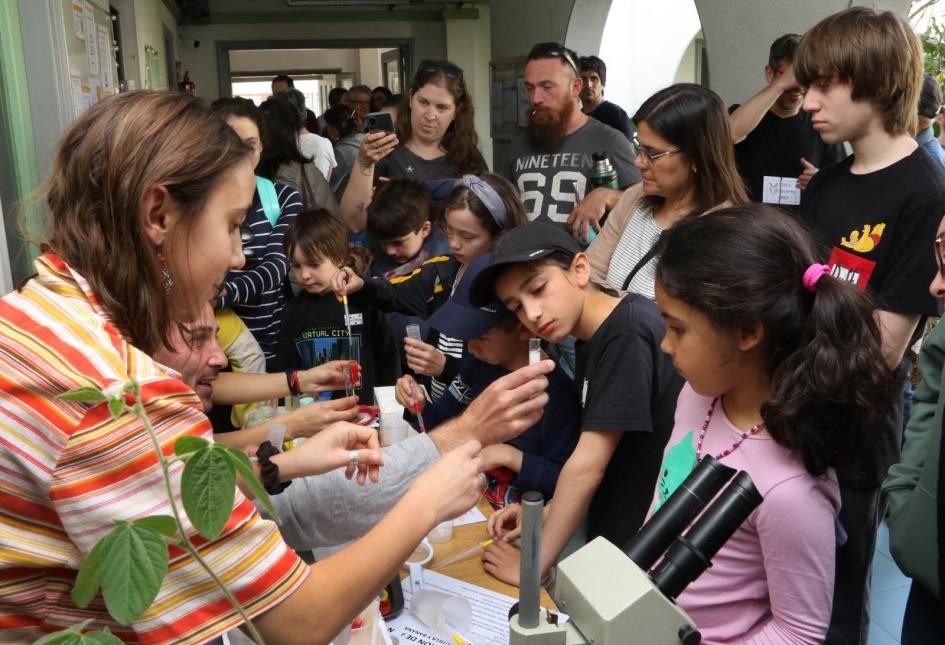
397 253 581 508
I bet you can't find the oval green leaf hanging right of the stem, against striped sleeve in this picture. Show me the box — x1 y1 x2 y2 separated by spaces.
181 439 236 540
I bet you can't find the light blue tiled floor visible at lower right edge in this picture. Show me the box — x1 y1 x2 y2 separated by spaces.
869 524 911 645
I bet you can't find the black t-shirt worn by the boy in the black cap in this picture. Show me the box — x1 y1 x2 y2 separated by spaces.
574 294 683 548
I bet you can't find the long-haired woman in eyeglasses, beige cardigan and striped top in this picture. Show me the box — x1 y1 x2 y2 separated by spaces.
587 83 748 300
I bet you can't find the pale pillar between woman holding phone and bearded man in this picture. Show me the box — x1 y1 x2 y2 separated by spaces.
446 5 492 167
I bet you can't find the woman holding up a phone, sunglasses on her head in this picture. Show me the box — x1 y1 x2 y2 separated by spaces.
341 60 488 232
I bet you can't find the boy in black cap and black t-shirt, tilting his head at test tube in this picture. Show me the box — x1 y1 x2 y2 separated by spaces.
470 222 683 584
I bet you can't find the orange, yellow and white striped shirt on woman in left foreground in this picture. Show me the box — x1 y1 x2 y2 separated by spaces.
0 254 308 643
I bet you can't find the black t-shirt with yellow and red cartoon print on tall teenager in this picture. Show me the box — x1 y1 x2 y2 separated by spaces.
801 147 945 316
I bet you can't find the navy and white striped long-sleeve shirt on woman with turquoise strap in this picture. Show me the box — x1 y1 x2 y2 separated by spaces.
222 182 302 372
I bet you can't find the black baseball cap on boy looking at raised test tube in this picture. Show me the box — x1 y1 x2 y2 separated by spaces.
469 221 581 306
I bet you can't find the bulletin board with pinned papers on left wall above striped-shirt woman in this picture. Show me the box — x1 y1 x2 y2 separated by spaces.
62 0 119 116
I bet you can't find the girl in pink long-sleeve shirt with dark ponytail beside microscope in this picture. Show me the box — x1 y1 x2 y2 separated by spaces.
654 205 893 643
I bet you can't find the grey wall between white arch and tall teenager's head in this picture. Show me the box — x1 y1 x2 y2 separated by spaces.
695 0 910 105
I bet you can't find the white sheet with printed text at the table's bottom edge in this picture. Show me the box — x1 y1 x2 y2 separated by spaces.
387 569 518 645
